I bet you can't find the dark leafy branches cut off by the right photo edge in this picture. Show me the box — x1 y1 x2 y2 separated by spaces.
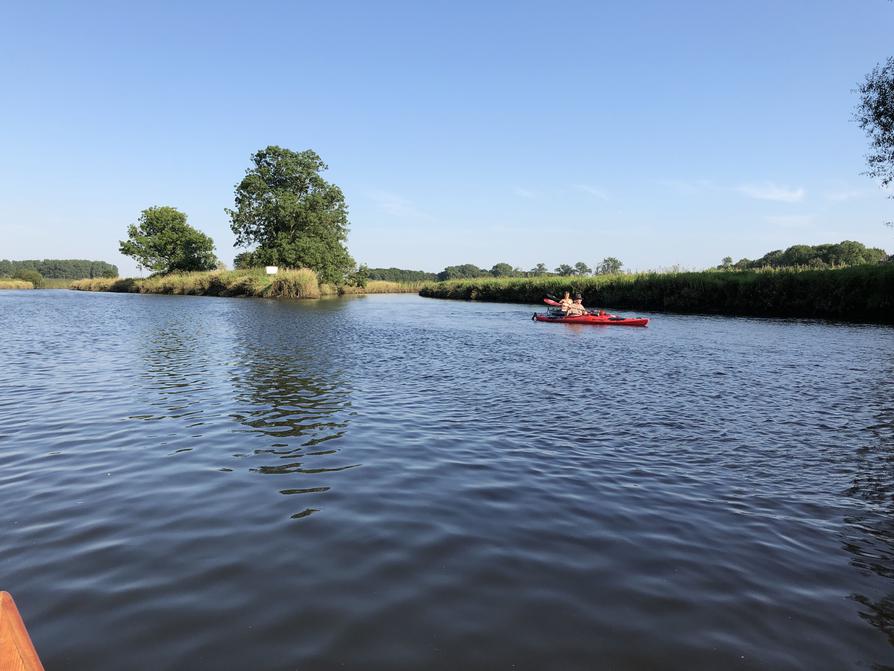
854 57 894 198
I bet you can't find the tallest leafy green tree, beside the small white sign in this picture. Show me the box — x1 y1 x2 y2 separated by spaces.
226 145 354 284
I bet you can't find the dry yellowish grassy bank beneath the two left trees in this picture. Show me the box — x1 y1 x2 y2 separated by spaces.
70 268 425 298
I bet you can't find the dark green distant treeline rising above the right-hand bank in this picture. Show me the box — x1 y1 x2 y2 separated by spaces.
718 240 889 270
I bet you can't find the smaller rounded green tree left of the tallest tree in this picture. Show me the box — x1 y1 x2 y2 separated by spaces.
118 207 217 273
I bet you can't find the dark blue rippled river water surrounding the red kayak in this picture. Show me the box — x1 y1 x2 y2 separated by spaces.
0 291 894 671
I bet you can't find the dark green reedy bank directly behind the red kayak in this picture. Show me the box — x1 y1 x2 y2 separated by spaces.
420 263 894 323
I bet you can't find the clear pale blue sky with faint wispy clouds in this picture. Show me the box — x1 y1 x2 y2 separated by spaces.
0 0 894 274
